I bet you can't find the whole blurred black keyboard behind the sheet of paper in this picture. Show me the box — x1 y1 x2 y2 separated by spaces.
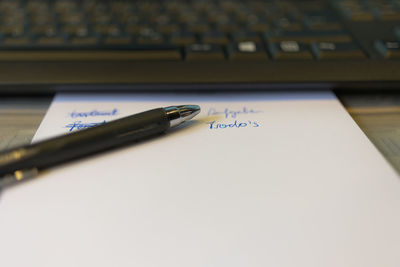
0 0 400 93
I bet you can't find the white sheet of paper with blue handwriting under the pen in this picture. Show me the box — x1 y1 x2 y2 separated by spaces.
0 92 400 267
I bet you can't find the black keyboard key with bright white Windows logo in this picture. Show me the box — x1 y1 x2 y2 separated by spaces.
228 42 268 60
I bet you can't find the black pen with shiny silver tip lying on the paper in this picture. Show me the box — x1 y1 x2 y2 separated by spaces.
0 105 200 188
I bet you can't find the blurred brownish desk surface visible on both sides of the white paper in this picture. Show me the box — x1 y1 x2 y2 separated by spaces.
0 92 400 173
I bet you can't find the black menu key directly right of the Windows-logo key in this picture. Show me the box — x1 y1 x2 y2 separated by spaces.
269 41 313 59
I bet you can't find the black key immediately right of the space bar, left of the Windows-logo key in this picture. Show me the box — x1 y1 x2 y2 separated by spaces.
185 44 225 61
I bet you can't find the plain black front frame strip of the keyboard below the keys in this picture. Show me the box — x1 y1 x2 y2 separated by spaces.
0 59 400 94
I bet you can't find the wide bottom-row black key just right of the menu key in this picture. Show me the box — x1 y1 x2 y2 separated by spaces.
311 42 365 59
